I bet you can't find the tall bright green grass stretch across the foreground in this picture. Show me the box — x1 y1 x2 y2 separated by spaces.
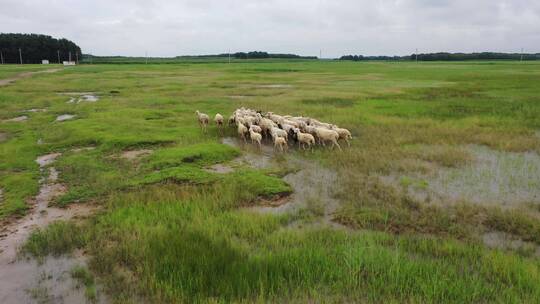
26 185 540 303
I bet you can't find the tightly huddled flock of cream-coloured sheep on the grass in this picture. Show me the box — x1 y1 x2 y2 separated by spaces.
196 107 352 152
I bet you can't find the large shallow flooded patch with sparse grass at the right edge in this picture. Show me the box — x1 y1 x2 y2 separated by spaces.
381 146 540 206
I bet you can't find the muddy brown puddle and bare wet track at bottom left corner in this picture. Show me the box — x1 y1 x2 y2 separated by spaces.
0 153 100 303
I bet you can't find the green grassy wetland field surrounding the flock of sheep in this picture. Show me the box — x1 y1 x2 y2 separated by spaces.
0 60 540 303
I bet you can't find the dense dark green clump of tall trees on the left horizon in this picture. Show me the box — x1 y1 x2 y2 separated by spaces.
0 33 82 63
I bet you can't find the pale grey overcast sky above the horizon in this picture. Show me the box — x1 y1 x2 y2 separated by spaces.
0 0 540 57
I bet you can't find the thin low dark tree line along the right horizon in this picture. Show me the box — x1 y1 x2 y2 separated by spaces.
339 52 540 61
